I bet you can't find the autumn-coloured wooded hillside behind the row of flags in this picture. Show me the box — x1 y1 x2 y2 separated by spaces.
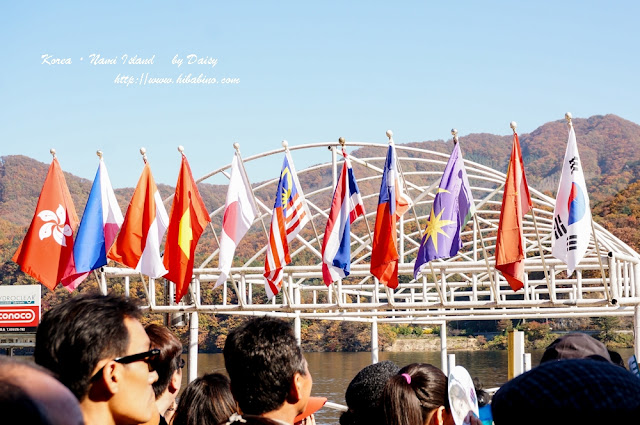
0 115 640 274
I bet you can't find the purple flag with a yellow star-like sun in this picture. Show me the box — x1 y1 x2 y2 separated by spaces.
413 144 475 278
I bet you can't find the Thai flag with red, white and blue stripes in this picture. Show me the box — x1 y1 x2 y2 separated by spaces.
322 150 364 286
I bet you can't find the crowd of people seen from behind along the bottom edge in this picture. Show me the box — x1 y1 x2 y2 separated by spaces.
0 294 640 425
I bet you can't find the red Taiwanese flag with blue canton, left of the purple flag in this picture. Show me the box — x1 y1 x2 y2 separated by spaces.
370 143 411 289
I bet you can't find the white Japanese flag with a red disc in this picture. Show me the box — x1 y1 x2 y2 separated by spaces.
215 154 258 288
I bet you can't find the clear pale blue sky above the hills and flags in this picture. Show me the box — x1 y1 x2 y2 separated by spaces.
0 1 640 187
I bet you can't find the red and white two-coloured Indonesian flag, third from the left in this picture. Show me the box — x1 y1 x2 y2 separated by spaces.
107 162 169 278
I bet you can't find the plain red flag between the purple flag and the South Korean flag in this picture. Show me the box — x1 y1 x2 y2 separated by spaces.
496 133 532 291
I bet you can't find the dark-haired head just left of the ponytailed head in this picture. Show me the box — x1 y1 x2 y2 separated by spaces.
340 360 400 425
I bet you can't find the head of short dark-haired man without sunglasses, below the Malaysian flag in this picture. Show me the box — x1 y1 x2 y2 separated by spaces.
224 317 312 420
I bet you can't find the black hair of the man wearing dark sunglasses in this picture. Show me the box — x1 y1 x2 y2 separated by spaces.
34 293 142 401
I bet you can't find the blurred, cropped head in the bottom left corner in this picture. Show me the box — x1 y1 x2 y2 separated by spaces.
0 357 84 425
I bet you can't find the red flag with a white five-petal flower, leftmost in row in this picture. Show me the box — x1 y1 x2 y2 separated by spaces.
12 157 78 290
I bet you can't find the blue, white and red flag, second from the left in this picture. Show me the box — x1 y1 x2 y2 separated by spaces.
62 158 124 291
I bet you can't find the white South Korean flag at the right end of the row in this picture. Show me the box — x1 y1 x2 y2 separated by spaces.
552 126 591 276
